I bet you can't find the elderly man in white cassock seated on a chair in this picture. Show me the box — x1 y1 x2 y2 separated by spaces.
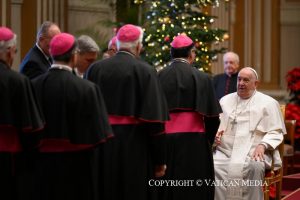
214 67 286 200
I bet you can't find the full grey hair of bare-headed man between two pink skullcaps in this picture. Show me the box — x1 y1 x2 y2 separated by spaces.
77 35 100 53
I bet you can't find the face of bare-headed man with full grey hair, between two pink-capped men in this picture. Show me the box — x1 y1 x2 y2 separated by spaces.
75 52 98 74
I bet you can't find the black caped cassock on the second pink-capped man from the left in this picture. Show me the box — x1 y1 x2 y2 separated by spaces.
33 68 112 200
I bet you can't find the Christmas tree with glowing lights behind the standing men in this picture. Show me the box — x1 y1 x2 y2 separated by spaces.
135 0 226 72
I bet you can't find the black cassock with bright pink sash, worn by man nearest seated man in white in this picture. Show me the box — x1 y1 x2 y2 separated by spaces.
159 60 221 200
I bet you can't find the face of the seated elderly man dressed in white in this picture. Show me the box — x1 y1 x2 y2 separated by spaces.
237 69 258 99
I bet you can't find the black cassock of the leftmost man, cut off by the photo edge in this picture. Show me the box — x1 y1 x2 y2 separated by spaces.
0 61 44 200
